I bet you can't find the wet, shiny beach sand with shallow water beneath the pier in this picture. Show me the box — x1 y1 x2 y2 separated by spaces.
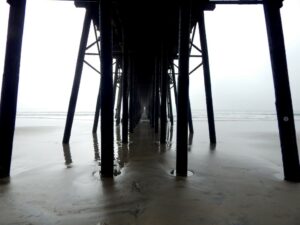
0 118 300 225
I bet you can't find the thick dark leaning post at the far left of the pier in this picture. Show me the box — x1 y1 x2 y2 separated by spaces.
0 0 26 178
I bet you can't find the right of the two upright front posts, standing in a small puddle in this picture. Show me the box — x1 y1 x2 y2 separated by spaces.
176 0 191 176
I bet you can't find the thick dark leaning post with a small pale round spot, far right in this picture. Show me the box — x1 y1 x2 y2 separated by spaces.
264 0 300 182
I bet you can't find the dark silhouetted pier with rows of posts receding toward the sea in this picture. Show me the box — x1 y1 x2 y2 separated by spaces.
0 0 300 181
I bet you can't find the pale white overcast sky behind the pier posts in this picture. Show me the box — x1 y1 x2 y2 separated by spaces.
0 0 300 111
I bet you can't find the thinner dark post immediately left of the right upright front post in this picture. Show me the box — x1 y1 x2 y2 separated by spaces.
160 46 168 144
